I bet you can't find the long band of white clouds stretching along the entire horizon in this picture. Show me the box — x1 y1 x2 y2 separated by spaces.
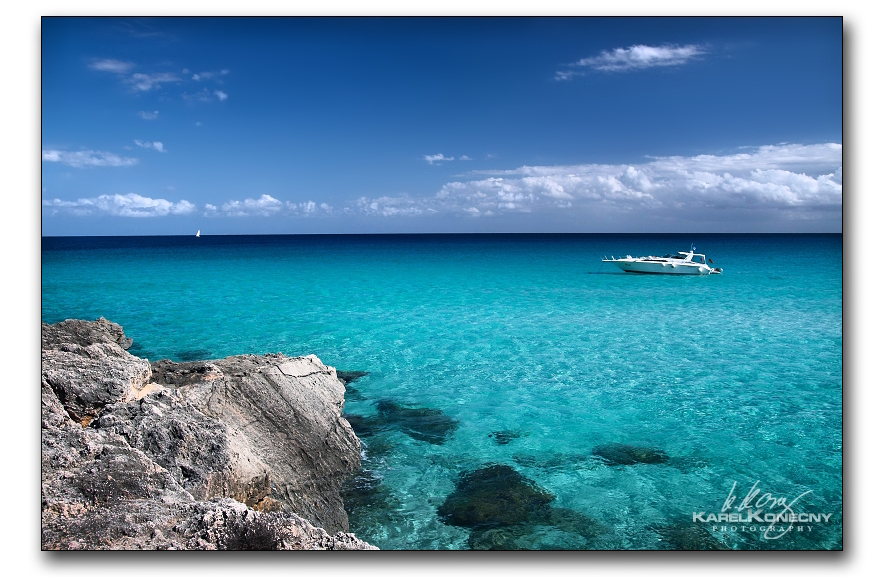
43 143 842 225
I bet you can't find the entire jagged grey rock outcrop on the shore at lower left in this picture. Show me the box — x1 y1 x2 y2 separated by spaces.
41 319 373 549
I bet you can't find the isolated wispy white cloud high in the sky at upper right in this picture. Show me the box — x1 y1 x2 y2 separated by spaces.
555 44 706 80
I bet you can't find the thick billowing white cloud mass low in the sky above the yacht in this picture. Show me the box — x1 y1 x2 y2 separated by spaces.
461 144 842 208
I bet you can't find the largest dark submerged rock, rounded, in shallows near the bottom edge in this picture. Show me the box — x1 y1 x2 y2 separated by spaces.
438 465 555 529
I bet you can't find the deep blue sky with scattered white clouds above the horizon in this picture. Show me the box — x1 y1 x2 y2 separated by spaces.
41 17 842 235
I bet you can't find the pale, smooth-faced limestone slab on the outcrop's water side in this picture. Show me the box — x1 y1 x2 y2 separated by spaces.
149 355 361 532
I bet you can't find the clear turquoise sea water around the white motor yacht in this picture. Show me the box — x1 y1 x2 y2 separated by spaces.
42 235 842 549
